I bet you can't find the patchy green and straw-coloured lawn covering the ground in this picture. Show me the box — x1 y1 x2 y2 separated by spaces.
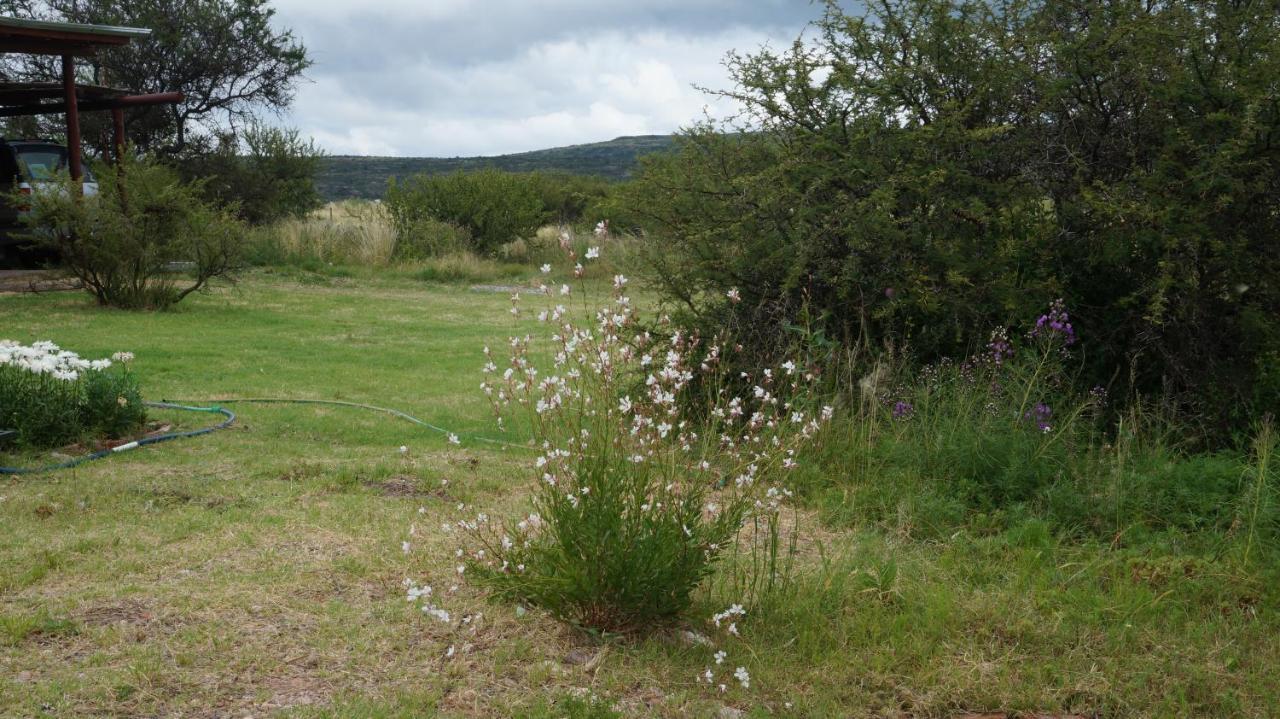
0 273 1280 716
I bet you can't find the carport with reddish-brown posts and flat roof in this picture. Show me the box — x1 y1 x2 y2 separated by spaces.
0 17 183 179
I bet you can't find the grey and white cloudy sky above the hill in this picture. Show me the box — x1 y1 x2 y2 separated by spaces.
273 0 820 156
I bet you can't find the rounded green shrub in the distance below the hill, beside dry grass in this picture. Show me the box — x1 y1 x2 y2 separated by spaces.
385 170 544 255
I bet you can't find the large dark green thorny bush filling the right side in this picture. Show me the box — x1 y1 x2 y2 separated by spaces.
622 0 1280 429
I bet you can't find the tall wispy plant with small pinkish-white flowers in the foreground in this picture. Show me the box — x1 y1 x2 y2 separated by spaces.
460 248 831 632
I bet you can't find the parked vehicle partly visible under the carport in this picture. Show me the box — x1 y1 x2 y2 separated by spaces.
0 138 97 267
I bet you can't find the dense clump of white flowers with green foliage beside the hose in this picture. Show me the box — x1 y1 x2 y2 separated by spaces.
0 339 145 448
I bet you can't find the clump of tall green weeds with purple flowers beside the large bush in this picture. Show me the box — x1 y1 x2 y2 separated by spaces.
797 301 1280 541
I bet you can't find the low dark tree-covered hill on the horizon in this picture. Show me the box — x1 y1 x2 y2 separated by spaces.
316 134 675 200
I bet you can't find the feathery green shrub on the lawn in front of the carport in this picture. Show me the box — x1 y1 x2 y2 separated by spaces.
19 159 246 308
